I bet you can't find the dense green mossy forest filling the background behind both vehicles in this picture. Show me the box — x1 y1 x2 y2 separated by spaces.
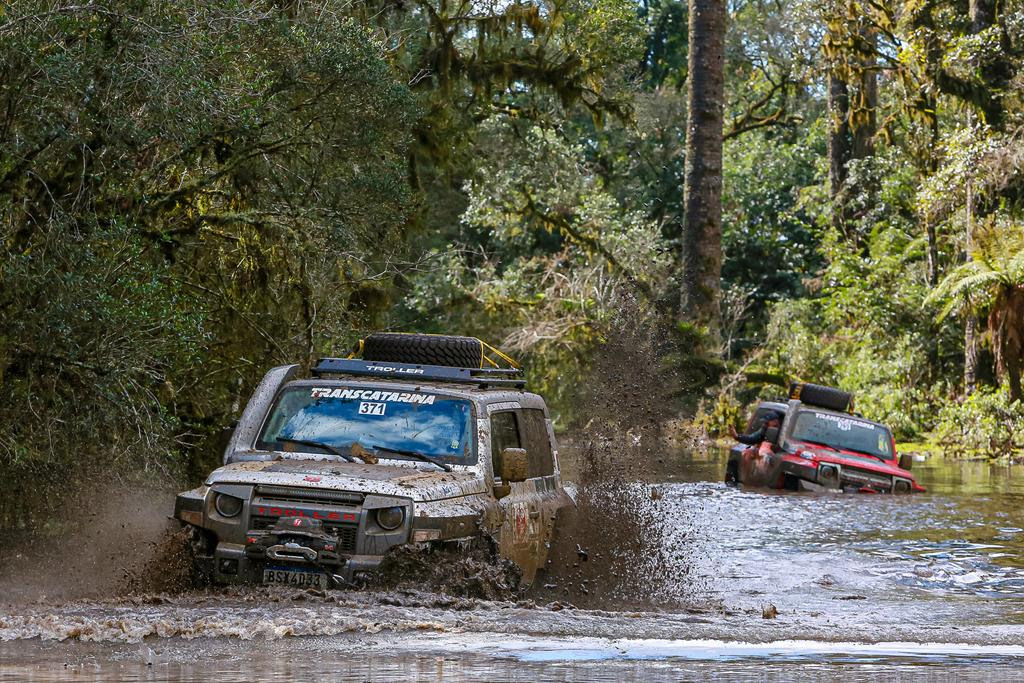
0 0 1024 529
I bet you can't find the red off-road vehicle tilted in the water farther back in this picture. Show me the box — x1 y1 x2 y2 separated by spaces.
725 382 925 494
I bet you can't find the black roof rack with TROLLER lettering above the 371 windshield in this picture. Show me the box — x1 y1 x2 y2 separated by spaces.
311 358 526 389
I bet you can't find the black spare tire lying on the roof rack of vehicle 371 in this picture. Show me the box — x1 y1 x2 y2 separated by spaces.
356 332 484 368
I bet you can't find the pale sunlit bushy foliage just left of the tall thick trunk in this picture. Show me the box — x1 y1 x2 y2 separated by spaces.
407 119 670 419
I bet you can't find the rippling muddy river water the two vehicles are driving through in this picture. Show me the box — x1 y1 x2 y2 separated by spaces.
0 454 1024 681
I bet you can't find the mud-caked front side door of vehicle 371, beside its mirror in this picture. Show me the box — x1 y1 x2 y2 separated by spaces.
490 409 554 584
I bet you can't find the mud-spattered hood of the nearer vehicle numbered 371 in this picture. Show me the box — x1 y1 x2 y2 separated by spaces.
206 459 486 502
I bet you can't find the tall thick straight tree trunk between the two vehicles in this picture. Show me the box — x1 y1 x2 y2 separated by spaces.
680 0 726 341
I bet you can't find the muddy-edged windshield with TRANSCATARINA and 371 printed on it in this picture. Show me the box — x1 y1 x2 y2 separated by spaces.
257 386 476 465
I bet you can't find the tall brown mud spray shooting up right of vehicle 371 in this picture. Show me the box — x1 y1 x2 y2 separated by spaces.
530 304 700 609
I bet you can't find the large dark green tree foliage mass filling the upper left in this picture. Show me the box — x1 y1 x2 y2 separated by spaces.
0 0 416 525
